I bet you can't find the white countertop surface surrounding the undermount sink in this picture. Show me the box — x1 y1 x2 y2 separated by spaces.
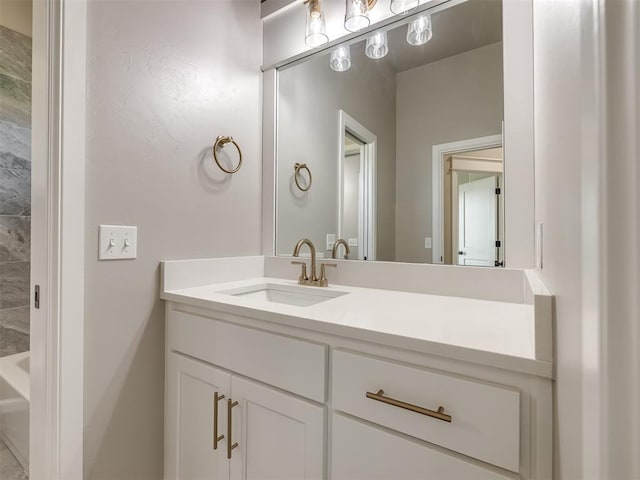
161 277 552 377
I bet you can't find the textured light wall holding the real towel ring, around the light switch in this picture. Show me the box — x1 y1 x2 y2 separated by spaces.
84 0 262 479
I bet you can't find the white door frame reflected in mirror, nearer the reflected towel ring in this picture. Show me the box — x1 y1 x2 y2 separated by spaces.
337 110 378 260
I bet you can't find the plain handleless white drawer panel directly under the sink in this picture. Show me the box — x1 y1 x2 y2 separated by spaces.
167 310 327 402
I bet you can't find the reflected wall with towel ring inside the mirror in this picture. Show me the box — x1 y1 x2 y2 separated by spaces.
276 44 395 260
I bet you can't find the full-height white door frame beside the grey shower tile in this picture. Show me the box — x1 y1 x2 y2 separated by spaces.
29 0 87 479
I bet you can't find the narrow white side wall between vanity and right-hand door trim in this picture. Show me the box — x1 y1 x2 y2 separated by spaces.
534 2 595 479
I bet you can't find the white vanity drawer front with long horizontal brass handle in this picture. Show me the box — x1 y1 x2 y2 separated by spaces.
332 350 520 472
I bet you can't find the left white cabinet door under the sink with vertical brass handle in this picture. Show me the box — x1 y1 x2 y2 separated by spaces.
164 353 231 480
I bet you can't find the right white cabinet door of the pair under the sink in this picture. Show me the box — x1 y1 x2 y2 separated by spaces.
230 376 325 480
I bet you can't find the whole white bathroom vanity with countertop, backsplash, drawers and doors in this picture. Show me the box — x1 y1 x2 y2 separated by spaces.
161 257 553 479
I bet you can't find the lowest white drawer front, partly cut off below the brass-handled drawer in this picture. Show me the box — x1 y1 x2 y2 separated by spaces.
331 414 512 480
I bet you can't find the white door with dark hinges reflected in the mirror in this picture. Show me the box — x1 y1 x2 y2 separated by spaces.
458 176 498 267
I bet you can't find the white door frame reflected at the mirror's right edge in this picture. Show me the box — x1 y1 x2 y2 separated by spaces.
431 134 504 264
